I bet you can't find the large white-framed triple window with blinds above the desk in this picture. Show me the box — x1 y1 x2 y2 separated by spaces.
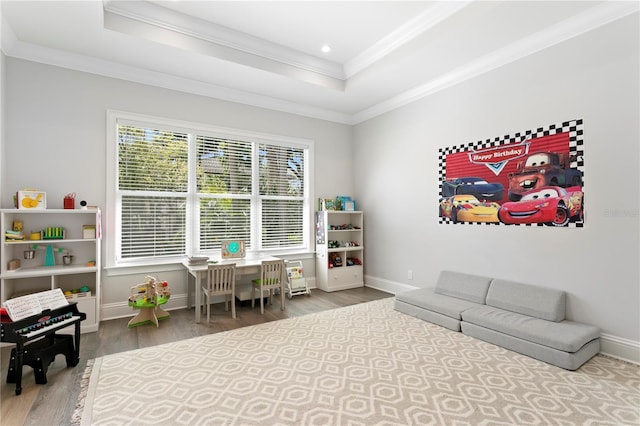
107 112 312 265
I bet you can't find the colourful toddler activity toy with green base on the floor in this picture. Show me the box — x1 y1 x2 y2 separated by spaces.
128 275 171 328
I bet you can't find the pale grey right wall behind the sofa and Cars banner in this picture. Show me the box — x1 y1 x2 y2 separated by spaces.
354 14 640 362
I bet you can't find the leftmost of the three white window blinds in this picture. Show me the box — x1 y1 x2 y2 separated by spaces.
118 125 189 259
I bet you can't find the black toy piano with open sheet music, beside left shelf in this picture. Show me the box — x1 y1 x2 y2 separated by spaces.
0 302 87 395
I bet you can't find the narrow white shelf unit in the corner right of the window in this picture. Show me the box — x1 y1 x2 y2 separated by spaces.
316 210 364 291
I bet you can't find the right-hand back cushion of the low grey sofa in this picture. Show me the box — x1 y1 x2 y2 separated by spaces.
486 279 566 322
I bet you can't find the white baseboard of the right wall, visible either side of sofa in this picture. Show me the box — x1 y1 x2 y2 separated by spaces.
364 275 640 365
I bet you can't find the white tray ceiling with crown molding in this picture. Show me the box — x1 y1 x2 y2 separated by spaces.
1 0 638 124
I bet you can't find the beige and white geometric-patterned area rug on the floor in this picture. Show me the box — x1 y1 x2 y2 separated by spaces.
78 298 640 426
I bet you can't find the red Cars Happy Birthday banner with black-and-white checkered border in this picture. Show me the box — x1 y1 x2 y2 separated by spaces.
438 119 585 228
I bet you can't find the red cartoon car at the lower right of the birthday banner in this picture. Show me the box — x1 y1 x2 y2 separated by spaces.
498 186 583 226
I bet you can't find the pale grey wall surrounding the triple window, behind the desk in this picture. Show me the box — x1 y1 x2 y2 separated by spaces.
0 58 353 313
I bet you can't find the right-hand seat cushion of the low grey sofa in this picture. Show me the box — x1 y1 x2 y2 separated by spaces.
462 305 600 352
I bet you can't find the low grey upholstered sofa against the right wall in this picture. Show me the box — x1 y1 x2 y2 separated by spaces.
394 271 600 370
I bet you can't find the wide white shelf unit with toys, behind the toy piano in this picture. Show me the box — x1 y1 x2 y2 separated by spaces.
0 209 101 333
